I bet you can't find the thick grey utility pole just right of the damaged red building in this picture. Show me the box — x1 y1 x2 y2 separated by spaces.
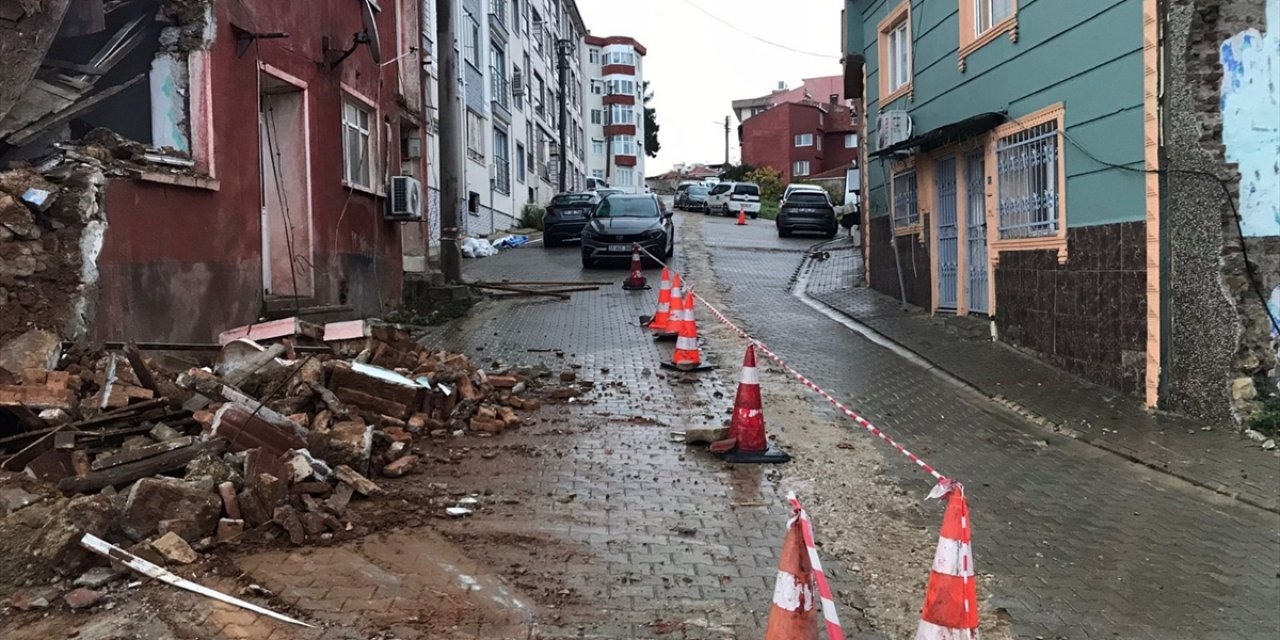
435 0 465 284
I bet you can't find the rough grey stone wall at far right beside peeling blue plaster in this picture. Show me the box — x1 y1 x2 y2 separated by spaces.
1161 0 1280 420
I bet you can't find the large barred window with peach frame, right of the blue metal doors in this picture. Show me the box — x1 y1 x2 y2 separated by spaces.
996 122 1061 239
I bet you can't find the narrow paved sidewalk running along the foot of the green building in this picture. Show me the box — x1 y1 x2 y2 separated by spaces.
806 244 1280 512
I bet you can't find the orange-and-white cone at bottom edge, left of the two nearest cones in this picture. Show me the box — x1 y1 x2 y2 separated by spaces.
764 506 818 640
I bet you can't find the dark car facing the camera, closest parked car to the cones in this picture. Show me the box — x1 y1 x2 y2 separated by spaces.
582 193 676 269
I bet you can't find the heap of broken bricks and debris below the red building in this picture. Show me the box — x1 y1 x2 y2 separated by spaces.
0 319 547 605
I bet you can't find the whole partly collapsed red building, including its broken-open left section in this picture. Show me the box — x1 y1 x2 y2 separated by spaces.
0 0 425 343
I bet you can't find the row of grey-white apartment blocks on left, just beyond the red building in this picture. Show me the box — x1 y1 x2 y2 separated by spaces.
404 0 588 271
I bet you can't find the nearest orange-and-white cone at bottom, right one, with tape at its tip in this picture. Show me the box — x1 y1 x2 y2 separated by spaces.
915 480 978 640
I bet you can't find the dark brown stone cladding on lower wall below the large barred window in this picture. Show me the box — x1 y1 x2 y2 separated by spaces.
996 223 1147 396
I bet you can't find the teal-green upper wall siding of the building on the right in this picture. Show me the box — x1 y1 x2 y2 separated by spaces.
849 0 1146 227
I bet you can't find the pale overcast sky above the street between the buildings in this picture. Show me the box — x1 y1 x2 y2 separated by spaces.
577 0 844 175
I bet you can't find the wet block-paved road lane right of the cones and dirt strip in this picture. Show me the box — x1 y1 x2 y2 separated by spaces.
695 211 1280 639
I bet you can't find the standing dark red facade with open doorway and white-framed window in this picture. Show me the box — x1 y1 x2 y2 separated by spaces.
92 0 425 342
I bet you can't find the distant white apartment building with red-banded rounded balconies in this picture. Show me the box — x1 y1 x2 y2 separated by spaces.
580 36 648 192
